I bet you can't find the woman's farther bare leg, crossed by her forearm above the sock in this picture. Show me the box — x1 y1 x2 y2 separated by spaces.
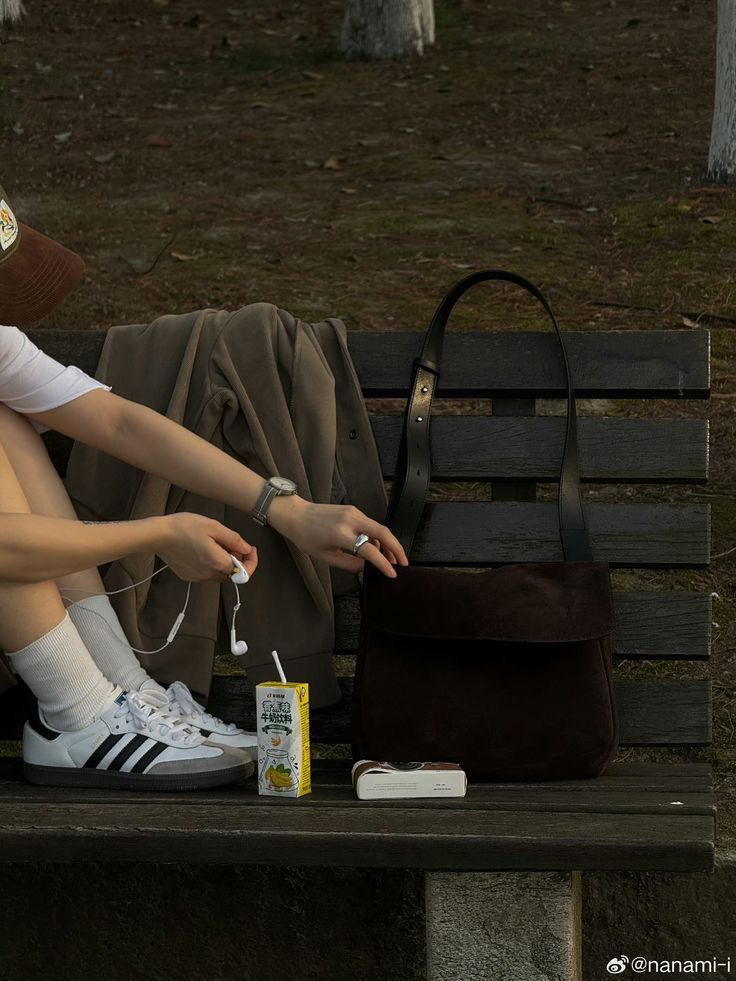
0 404 105 602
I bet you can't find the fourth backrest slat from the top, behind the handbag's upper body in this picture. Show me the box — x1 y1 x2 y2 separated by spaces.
335 591 712 660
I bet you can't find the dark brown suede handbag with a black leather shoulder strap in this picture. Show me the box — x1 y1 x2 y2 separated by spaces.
352 270 618 781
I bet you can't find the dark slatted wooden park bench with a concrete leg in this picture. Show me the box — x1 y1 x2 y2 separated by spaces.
0 318 715 981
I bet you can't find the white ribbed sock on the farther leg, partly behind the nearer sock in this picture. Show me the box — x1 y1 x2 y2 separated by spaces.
67 594 150 691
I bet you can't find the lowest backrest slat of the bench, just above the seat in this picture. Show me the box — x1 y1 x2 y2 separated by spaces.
209 675 711 746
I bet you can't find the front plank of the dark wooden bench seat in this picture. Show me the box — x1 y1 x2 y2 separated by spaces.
0 793 715 871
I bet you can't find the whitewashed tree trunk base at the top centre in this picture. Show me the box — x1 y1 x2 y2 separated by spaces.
340 0 434 58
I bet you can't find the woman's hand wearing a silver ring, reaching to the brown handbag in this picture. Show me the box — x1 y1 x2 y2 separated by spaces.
268 494 409 578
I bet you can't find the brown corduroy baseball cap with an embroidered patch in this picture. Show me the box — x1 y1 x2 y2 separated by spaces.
0 187 84 327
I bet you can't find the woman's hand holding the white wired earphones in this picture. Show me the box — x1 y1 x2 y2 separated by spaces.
157 511 258 582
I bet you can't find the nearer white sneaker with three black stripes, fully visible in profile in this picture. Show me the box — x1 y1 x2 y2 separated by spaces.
23 691 254 790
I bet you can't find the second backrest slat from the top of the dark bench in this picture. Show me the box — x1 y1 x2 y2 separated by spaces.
371 415 708 484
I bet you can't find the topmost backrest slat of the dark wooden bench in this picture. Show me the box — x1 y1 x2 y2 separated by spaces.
28 328 710 398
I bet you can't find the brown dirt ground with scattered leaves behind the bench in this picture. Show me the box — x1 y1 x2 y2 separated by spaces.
0 0 736 841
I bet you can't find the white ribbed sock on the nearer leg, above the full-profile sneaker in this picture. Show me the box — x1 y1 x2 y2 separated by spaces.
7 613 120 731
